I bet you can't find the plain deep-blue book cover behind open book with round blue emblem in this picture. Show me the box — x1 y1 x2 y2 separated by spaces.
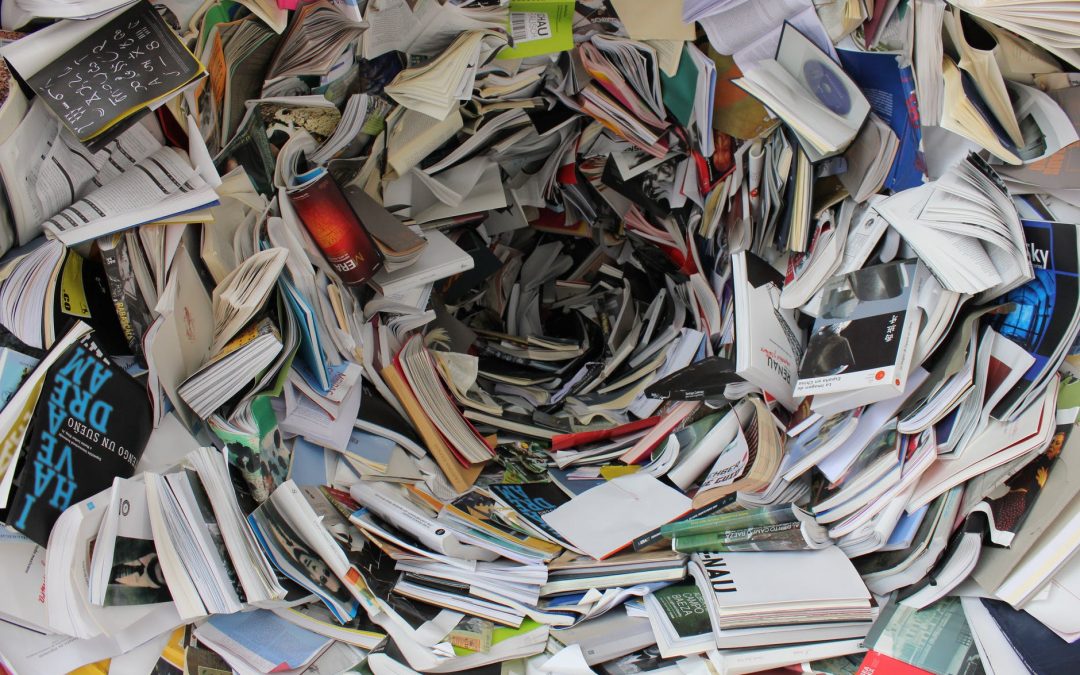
837 50 927 192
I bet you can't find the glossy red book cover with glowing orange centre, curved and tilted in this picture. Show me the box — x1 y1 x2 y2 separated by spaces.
288 173 382 286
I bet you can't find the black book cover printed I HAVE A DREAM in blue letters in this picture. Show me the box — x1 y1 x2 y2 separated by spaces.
8 334 152 546
